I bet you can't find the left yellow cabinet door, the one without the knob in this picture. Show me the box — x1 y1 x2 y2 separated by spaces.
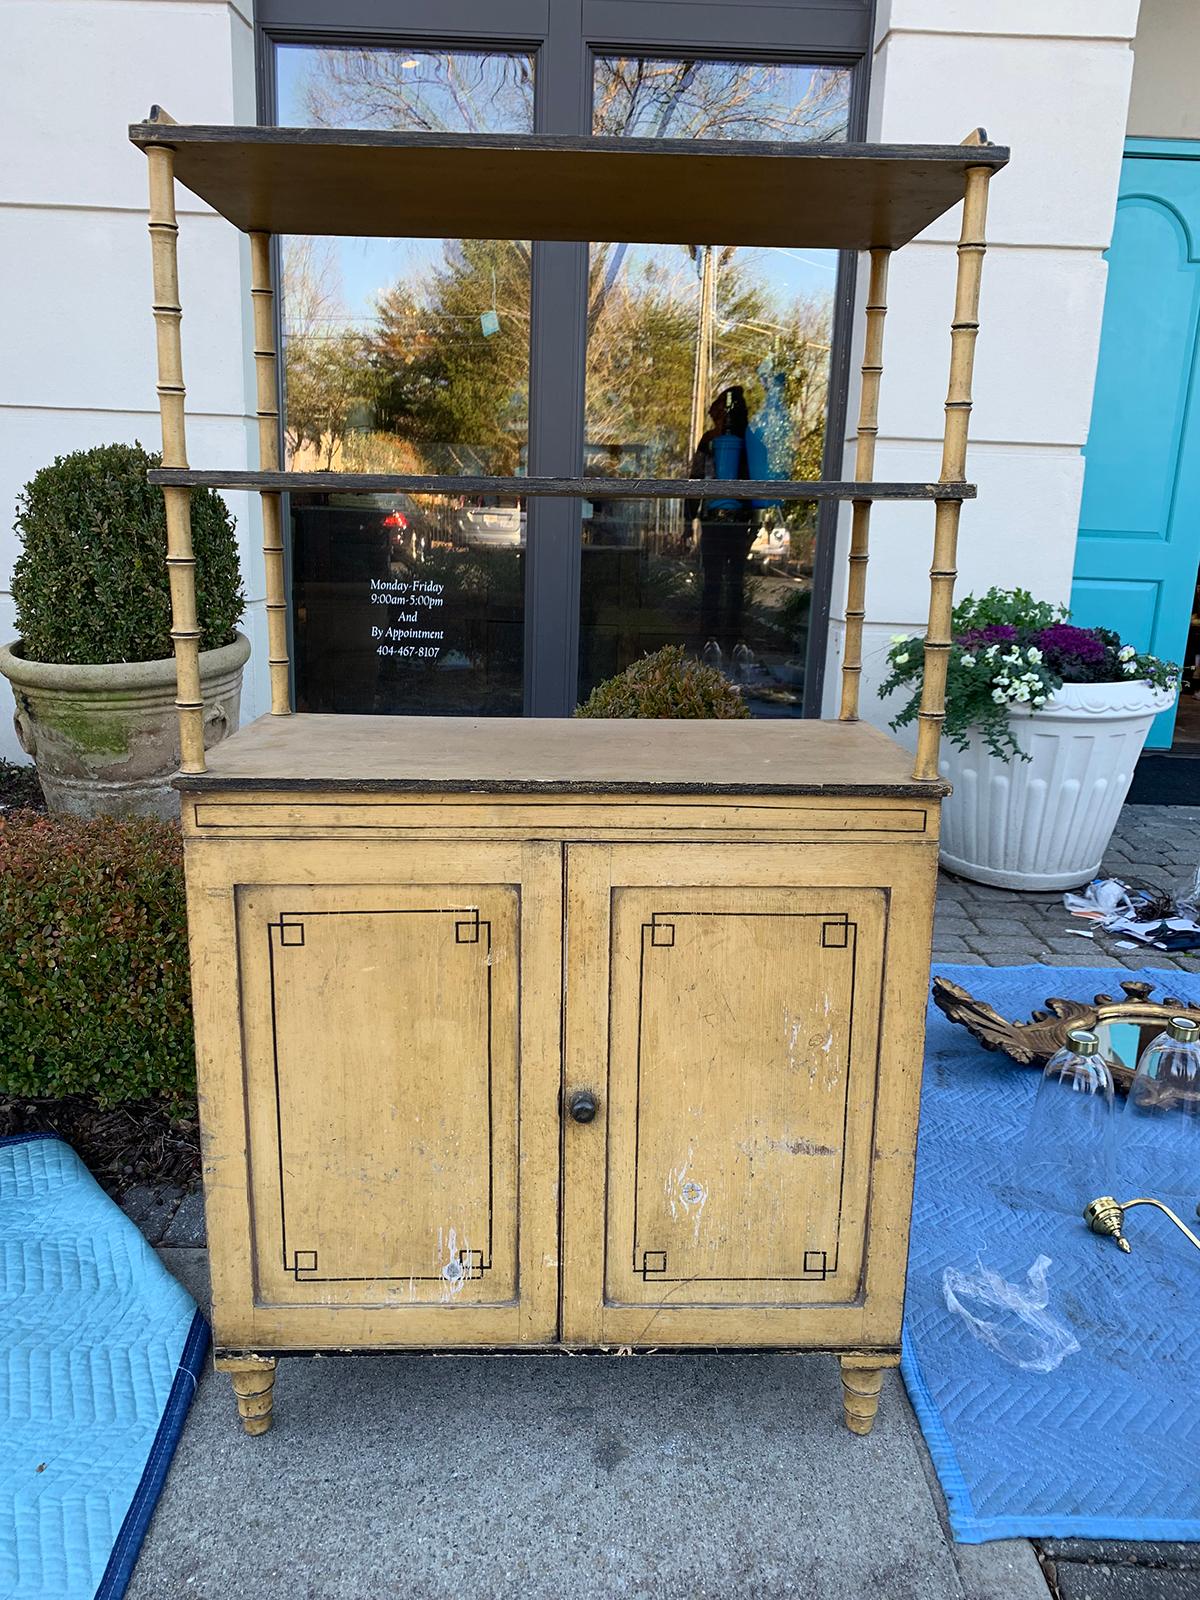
190 843 560 1346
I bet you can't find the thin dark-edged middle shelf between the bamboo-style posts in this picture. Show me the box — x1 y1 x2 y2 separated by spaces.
147 467 976 501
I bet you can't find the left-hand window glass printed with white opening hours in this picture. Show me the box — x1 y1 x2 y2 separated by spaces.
275 45 533 715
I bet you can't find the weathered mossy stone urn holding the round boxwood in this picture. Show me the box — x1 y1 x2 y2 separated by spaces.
0 634 250 819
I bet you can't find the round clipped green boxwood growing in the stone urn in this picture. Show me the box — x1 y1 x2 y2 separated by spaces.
13 445 245 666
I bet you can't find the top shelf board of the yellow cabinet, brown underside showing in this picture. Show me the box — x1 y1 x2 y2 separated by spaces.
130 122 1008 250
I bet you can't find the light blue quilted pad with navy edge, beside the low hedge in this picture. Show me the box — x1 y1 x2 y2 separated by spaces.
0 1134 208 1600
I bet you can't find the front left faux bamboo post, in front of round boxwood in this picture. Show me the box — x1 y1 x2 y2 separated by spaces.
146 123 205 773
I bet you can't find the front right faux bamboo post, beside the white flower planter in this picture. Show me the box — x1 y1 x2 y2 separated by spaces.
912 134 992 779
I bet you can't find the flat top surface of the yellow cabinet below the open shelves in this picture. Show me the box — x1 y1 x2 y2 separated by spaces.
176 715 947 798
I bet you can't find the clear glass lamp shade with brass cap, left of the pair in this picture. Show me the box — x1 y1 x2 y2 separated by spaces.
1016 1029 1115 1216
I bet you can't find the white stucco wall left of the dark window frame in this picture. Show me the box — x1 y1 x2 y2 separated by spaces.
0 0 267 760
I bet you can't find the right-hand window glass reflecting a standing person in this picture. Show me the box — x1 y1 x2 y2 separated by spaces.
579 56 848 715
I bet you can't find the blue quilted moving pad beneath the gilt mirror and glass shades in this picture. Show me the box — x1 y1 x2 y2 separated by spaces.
902 966 1200 1544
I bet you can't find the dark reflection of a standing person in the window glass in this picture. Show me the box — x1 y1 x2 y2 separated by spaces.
683 384 754 654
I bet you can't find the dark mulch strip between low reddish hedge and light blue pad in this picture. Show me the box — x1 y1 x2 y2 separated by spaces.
0 1094 200 1198
